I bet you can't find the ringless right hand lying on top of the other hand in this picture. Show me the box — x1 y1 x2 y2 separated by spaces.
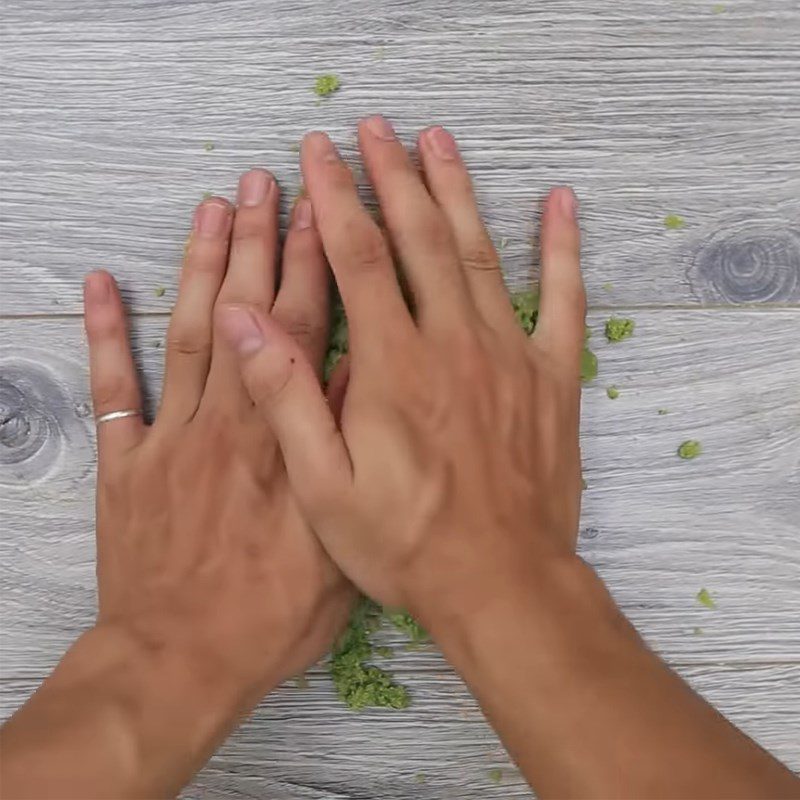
217 118 585 623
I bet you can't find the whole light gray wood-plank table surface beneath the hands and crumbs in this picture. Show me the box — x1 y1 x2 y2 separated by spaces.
0 0 800 800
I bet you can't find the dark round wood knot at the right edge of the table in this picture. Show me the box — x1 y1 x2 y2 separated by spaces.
687 220 800 304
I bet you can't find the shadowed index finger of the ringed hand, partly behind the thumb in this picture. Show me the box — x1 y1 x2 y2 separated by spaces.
272 197 330 376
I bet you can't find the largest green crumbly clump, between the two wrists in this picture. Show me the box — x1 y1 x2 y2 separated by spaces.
330 598 411 711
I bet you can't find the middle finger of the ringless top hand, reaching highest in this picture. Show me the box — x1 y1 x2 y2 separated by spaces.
358 117 474 328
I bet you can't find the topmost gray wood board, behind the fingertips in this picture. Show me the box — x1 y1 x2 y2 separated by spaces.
0 0 800 315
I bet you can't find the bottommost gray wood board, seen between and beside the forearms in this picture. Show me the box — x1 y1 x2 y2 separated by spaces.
0 664 800 800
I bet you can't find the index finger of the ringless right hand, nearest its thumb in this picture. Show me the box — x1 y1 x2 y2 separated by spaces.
302 133 414 358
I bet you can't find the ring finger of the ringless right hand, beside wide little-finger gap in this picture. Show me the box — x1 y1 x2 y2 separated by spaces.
419 127 515 331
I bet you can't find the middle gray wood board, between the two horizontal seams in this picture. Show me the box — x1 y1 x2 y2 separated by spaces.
0 309 800 677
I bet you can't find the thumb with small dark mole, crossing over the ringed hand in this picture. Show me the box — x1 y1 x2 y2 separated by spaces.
216 305 352 516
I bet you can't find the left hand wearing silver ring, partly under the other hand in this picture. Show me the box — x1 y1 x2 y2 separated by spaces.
85 170 354 788
